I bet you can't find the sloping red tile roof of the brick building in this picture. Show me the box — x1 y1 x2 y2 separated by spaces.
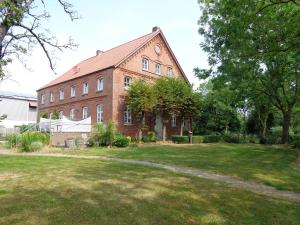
39 30 160 90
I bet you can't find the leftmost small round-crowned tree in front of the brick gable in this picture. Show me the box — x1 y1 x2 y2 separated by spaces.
125 80 156 140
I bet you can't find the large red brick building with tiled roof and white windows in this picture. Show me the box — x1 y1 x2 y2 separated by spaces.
37 27 189 137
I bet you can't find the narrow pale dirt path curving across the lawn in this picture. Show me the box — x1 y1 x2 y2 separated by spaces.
0 150 300 202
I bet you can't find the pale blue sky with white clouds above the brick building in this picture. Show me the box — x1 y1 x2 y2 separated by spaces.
0 0 207 93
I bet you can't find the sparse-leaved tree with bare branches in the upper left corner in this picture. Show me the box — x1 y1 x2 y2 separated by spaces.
0 0 78 79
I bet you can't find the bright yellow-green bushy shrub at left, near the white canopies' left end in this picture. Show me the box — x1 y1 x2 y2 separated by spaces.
20 131 49 152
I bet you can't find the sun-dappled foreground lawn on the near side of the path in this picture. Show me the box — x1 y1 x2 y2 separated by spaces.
0 156 300 225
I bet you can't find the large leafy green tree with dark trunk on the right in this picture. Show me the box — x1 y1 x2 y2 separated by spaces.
196 0 300 143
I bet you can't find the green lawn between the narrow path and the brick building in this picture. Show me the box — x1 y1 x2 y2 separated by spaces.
44 144 300 192
